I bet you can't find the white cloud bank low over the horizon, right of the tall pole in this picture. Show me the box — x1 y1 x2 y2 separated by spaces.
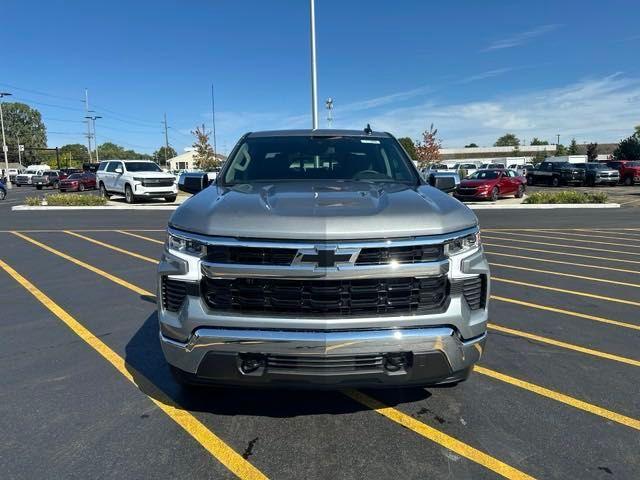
336 74 640 147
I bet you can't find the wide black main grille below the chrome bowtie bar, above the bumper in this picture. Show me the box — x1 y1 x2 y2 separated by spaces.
201 276 448 315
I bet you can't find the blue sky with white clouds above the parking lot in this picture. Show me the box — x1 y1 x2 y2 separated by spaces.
0 0 640 152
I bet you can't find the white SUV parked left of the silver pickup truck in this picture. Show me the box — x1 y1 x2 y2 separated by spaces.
96 160 178 203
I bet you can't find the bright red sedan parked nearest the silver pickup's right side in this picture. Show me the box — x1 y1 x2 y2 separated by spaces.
453 170 527 201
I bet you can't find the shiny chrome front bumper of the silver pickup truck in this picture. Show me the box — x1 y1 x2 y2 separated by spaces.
160 327 486 386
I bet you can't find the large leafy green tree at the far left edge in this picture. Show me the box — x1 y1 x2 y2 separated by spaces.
2 102 47 164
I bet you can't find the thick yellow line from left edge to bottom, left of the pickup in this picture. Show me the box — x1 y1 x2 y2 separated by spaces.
0 260 267 479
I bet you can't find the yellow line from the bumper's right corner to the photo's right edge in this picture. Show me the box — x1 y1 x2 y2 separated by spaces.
474 365 640 430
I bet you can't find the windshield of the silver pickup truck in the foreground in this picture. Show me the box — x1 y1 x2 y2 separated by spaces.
224 136 419 185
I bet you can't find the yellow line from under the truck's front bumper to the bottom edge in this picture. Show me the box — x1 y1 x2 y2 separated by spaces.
344 390 533 480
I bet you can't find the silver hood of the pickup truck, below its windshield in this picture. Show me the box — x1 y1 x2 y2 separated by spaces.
169 181 477 240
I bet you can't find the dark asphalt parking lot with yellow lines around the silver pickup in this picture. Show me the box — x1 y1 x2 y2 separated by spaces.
0 207 640 479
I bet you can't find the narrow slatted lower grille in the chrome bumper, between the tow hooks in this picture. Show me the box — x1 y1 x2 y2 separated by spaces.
267 355 383 375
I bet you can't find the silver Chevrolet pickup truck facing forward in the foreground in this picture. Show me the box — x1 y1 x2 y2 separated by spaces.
157 130 489 388
